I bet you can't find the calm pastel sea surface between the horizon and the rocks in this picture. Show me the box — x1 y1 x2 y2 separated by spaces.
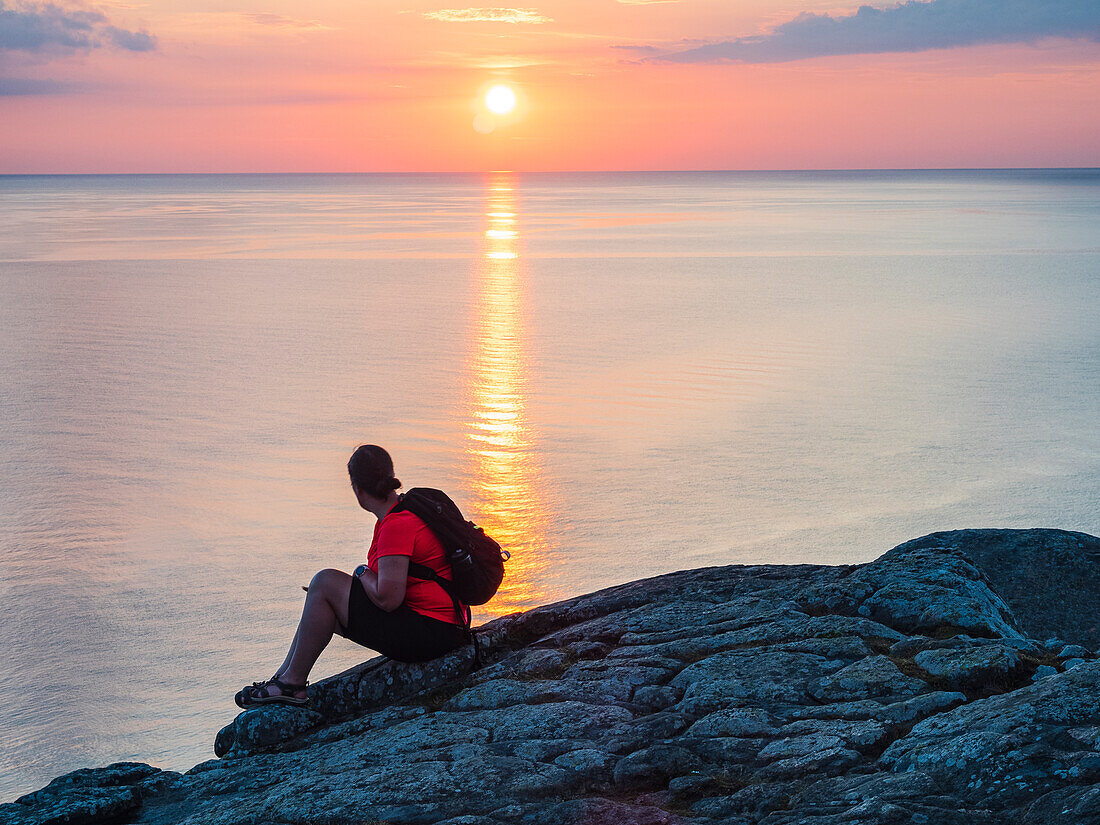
0 169 1100 800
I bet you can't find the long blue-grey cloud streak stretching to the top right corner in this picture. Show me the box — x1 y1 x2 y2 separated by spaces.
648 0 1100 63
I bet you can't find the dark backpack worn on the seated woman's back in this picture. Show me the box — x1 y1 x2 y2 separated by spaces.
391 487 509 628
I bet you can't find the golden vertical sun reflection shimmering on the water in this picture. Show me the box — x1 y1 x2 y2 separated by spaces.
463 173 548 616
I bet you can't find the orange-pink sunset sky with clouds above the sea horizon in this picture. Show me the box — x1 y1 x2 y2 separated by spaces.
0 0 1100 173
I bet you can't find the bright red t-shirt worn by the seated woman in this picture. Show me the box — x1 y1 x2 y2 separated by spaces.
366 510 465 624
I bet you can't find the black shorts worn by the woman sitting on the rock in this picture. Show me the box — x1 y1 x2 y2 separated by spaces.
338 580 468 662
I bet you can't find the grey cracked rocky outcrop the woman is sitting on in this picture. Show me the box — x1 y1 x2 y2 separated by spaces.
0 530 1100 825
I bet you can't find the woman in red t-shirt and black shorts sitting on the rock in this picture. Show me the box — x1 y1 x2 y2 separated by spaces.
235 444 466 707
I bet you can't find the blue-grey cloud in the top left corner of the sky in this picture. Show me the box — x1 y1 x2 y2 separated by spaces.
0 0 156 54
